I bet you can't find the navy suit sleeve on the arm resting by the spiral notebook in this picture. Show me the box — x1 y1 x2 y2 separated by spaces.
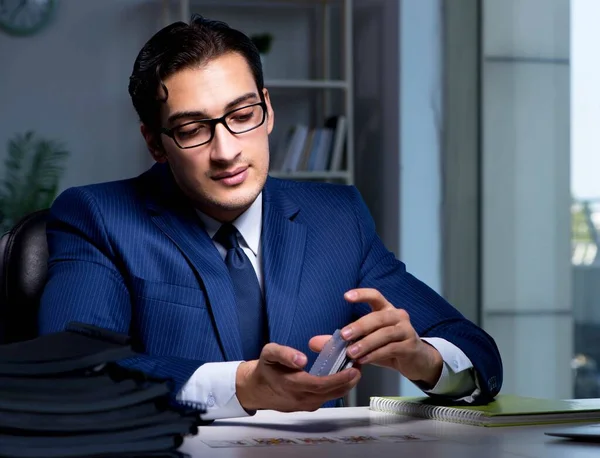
351 188 502 401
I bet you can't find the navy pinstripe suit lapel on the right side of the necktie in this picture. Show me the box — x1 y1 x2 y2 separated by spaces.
262 178 306 345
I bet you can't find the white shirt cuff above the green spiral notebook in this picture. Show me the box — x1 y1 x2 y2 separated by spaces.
421 337 479 398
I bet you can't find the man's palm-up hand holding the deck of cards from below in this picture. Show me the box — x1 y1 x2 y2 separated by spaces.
235 343 360 412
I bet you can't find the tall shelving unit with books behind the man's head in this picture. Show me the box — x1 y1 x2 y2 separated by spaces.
162 0 354 184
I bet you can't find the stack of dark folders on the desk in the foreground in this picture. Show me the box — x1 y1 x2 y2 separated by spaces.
0 323 201 458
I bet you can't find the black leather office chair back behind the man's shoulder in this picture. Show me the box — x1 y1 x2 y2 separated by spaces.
0 209 48 344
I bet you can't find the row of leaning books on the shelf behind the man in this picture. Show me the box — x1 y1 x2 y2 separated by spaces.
271 115 347 173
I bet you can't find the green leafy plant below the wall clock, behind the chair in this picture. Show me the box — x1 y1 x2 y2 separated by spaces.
0 131 69 233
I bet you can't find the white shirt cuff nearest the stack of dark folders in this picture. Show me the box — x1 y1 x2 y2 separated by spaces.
177 361 249 420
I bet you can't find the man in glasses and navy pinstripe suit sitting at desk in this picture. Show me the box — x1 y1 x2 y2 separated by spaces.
39 17 502 419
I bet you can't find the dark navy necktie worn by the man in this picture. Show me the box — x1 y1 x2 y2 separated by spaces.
213 223 266 361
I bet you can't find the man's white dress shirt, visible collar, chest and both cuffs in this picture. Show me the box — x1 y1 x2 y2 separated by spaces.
177 193 479 420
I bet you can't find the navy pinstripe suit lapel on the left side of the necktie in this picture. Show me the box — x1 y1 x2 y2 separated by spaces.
147 166 243 361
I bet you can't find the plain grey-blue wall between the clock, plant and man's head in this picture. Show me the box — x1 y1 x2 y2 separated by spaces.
0 0 160 189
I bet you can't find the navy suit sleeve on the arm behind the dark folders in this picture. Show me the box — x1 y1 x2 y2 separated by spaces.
38 188 203 394
